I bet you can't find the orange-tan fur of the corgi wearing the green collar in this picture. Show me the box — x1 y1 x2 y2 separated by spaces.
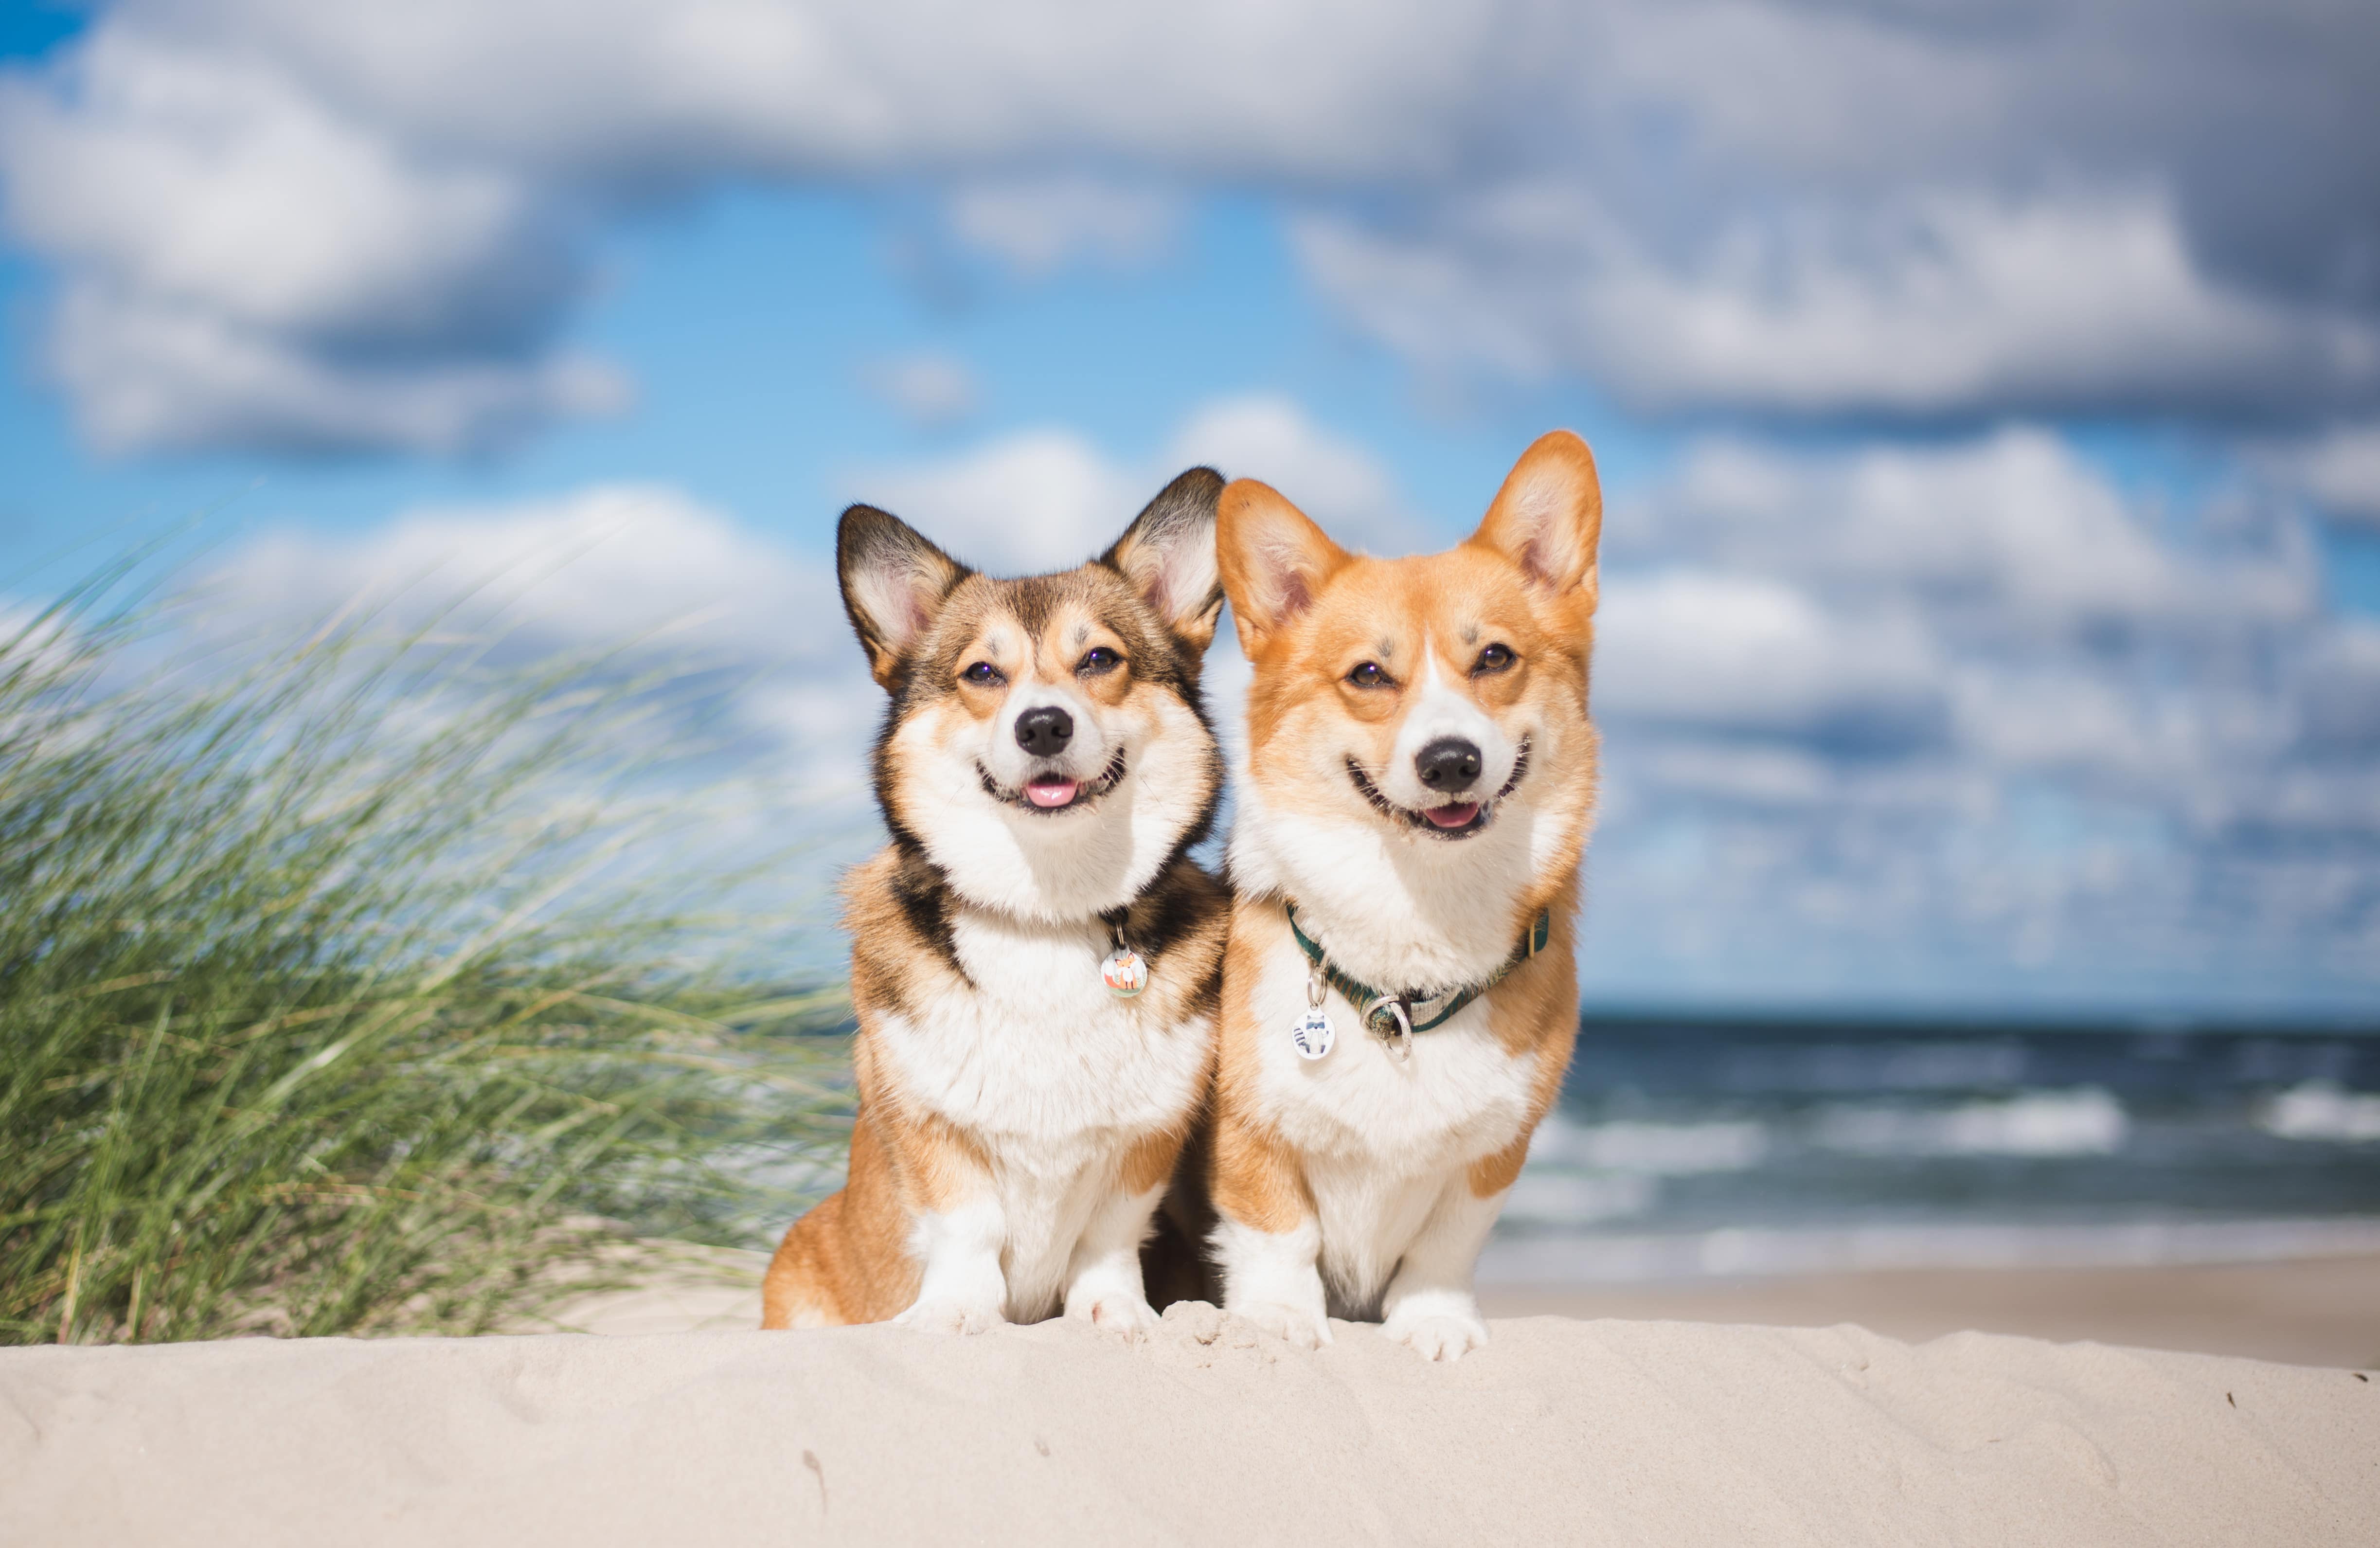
1204 431 1602 1353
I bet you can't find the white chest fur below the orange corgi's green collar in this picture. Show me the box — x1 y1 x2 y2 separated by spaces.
1250 924 1535 1314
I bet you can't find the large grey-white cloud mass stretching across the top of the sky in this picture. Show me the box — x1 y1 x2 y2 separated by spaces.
0 0 2380 450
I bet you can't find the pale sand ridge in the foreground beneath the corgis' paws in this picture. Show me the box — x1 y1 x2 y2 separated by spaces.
0 1308 2380 1548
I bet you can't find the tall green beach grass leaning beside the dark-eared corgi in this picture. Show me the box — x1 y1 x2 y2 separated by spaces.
0 559 847 1343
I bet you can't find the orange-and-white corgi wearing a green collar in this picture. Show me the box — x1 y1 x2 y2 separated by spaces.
1207 431 1602 1360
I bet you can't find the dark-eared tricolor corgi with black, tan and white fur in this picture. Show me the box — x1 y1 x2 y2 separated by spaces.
762 467 1228 1336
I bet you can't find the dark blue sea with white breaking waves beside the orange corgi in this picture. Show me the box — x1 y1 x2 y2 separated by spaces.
1480 1022 2380 1284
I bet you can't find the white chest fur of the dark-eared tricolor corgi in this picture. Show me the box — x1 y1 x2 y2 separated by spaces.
871 910 1214 1319
